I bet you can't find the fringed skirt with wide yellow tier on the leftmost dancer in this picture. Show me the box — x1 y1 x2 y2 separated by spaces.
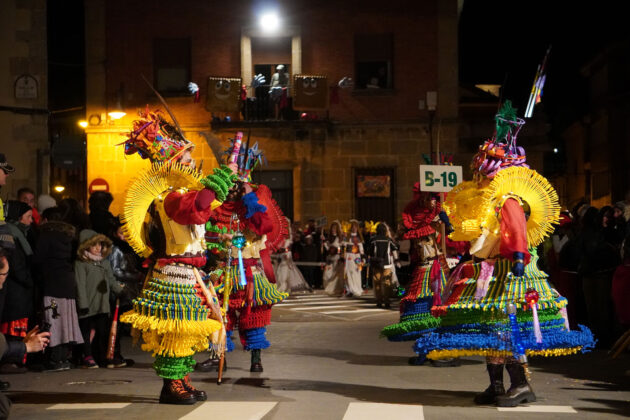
120 264 222 358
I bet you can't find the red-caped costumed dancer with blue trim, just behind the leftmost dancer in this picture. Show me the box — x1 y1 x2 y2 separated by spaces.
203 133 289 372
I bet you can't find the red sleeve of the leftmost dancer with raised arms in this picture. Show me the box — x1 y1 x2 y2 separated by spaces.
164 188 215 225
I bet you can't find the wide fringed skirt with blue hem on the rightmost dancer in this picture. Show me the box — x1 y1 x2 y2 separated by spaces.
414 256 595 359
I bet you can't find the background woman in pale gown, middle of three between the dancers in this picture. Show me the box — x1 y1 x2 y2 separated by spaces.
322 220 344 297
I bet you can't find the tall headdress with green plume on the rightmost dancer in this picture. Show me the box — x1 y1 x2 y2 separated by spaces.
471 101 529 178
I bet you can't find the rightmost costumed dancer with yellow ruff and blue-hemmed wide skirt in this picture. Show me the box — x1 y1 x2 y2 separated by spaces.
416 101 594 406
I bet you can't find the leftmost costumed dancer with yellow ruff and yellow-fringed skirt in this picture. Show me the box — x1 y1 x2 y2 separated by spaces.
120 109 235 404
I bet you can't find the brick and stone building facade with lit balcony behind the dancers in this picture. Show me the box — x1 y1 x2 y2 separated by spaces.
85 0 458 222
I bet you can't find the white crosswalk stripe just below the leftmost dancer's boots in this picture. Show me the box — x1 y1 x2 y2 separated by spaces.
180 401 278 420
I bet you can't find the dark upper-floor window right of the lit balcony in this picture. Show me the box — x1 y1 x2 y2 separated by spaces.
354 34 394 90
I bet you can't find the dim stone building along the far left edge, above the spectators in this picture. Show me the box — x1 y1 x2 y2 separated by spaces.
0 0 50 199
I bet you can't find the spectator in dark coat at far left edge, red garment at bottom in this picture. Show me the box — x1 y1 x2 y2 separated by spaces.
0 200 35 337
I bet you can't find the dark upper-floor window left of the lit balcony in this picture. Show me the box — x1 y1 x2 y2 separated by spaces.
153 38 191 96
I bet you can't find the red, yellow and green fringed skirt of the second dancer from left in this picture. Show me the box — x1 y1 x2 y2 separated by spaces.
215 266 289 334
